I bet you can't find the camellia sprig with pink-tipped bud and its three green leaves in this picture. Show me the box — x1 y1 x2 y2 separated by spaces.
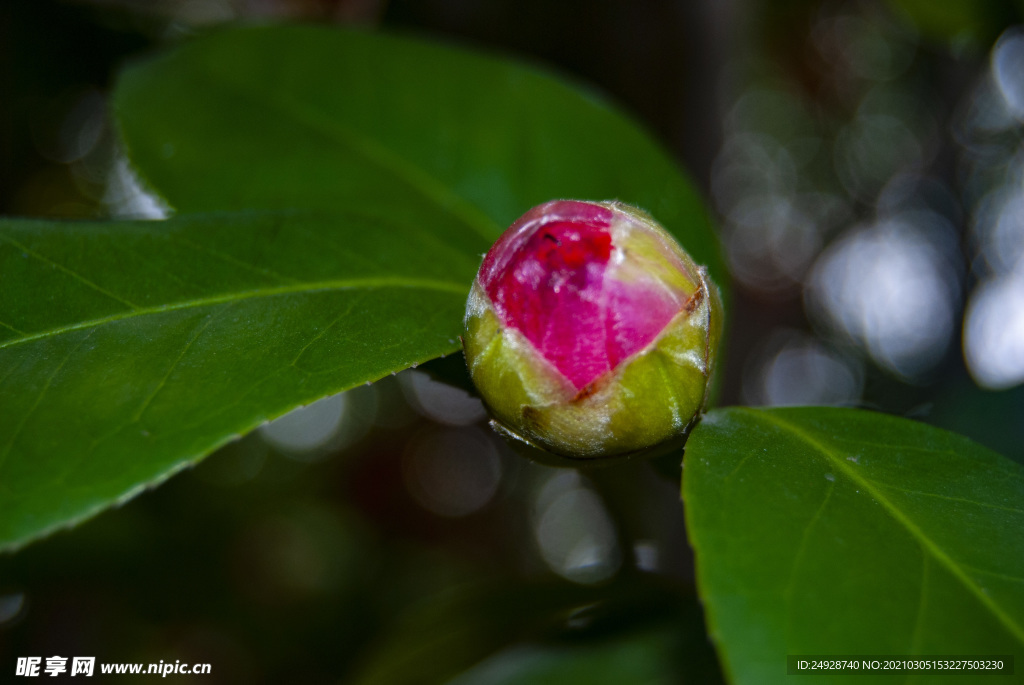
0 22 1024 683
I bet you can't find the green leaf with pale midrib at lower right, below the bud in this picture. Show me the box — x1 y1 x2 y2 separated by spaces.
683 408 1024 684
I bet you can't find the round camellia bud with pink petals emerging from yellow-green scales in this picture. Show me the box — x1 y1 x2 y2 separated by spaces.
463 200 722 458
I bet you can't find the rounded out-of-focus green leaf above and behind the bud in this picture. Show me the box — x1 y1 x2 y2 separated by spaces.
115 27 726 284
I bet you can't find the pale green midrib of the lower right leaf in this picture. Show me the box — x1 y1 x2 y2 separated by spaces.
735 406 1024 644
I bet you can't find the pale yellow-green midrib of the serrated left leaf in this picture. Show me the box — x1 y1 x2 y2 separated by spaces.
0 277 469 349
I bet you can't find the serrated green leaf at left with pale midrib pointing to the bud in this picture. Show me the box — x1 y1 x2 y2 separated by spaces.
0 212 468 548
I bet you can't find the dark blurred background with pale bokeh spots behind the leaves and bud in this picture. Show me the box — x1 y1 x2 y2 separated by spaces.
0 0 1024 684
